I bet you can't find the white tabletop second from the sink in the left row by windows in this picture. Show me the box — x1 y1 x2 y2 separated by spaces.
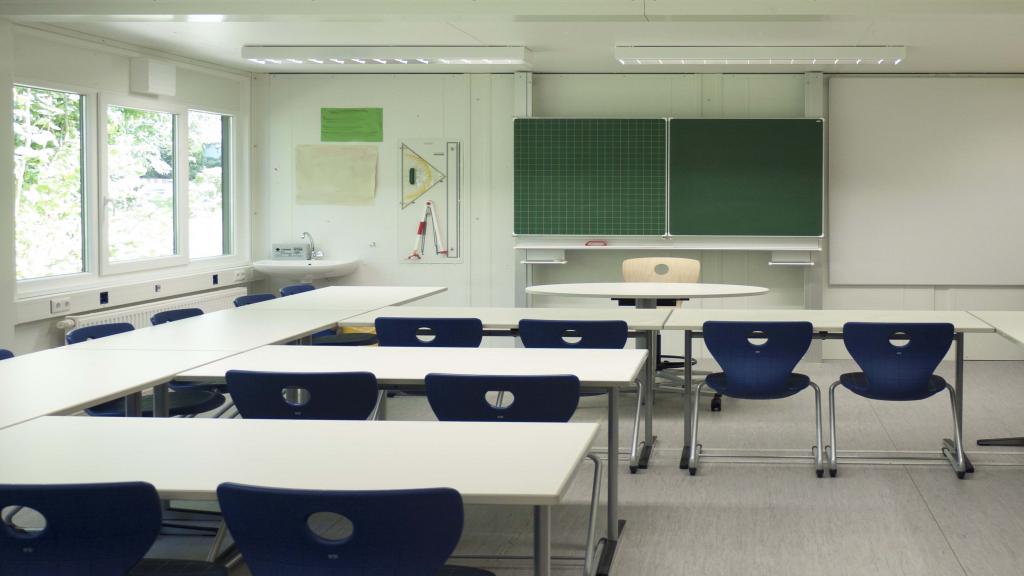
71 306 356 353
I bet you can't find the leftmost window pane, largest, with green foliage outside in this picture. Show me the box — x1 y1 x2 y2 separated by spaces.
13 86 85 280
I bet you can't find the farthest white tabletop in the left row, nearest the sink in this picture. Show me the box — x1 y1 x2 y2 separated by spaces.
246 286 447 312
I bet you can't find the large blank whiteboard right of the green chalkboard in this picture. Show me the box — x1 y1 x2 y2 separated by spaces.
828 77 1024 285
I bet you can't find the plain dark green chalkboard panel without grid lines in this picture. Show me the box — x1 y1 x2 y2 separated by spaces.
669 119 823 236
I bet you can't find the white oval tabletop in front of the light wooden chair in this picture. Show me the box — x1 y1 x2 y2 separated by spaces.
526 282 768 298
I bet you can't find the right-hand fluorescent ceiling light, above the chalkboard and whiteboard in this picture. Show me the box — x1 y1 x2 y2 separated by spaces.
615 46 906 66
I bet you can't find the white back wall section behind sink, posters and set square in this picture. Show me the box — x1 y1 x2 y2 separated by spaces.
254 74 513 305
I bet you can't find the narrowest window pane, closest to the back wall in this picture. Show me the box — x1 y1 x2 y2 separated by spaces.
188 111 230 258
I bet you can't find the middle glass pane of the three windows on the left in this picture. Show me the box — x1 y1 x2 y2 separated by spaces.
106 106 176 262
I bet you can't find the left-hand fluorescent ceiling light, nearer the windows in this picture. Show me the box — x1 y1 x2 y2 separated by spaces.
242 46 530 68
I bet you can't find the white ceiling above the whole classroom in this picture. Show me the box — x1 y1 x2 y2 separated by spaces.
0 0 1024 73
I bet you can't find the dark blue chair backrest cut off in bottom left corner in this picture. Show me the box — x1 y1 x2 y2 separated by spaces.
0 482 161 576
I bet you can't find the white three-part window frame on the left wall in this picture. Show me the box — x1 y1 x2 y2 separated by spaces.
12 77 252 301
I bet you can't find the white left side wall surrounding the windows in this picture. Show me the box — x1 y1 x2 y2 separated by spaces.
0 28 251 354
